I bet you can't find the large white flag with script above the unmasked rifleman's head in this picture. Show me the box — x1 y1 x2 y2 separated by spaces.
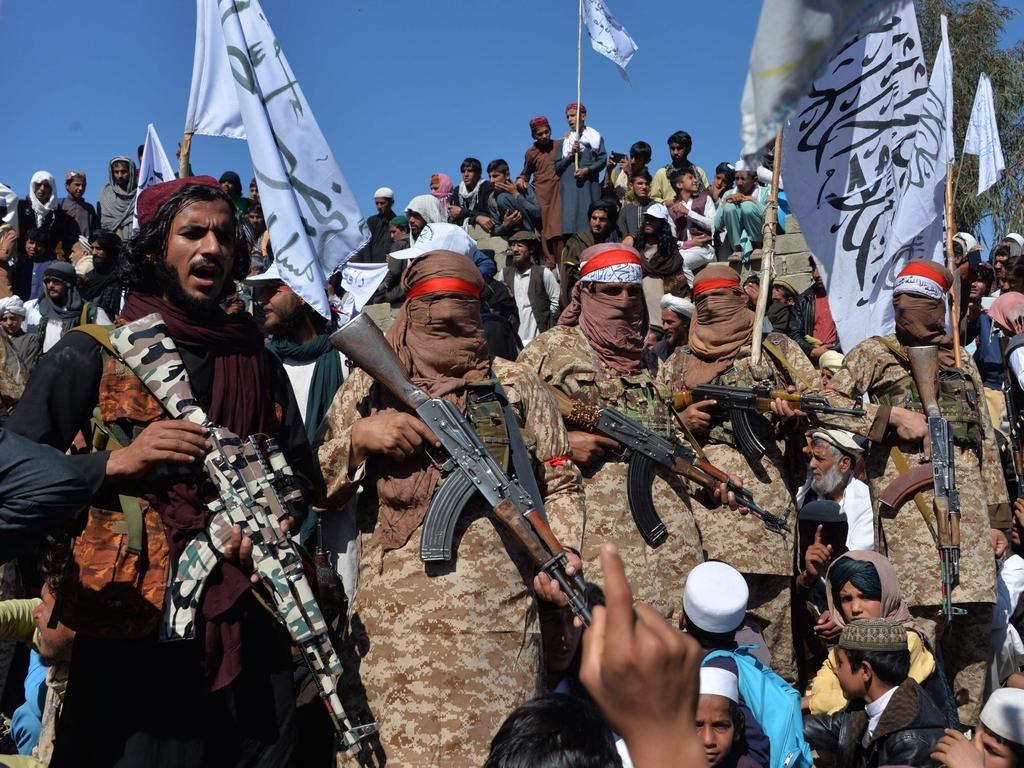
185 0 369 317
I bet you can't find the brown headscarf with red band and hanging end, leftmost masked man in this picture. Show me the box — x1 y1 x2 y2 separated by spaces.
374 251 490 551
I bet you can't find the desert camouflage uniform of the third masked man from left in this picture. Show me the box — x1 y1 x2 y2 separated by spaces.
662 334 816 681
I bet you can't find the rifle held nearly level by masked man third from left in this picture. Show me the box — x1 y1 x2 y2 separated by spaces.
673 384 866 459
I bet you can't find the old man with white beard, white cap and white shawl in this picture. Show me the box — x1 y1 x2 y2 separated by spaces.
797 429 874 550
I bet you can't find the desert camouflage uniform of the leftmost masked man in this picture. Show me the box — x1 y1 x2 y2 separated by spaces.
319 360 584 768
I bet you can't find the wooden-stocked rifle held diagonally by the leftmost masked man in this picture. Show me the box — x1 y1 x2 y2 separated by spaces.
331 314 591 627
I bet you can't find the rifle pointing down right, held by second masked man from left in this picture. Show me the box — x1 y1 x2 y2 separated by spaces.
549 387 790 547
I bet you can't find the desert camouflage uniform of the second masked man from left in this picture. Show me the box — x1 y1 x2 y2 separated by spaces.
519 326 703 617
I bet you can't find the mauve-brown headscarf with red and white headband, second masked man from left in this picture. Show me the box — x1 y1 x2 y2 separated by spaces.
558 243 650 376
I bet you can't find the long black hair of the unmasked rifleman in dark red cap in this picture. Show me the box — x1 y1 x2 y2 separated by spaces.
118 184 249 294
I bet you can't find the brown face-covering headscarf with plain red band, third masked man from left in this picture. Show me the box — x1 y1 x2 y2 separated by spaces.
683 264 754 389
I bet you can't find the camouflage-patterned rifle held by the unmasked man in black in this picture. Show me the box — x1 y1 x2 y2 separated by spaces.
111 314 377 750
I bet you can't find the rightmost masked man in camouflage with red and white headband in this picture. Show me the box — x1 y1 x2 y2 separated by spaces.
802 259 1012 724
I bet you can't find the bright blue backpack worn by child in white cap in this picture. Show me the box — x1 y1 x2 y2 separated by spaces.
703 645 814 768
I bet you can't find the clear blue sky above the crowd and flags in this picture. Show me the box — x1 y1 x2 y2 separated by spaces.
0 0 1024 215
